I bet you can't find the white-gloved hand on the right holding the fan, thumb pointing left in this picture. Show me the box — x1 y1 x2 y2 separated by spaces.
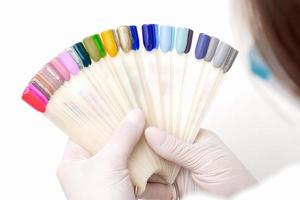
141 127 256 200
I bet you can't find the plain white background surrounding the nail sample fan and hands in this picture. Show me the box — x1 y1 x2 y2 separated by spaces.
0 0 300 200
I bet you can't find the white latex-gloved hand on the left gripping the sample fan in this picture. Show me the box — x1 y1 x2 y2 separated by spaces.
57 110 145 200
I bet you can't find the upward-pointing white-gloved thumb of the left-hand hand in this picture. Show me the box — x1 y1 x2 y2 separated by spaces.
95 109 145 165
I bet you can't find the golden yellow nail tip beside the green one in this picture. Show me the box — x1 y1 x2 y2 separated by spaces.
101 29 118 57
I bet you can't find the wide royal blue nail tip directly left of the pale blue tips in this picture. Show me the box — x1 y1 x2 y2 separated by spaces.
142 24 158 51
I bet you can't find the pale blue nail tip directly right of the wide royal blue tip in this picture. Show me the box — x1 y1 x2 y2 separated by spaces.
159 26 175 52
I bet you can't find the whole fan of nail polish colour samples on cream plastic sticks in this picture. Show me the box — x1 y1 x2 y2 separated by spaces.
22 24 237 193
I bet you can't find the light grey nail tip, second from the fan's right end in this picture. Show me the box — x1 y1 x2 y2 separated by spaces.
213 42 231 68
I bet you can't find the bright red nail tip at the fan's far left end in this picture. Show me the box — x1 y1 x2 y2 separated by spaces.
22 84 47 113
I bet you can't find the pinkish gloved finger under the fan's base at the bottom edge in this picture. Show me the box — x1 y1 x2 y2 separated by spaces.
138 183 176 200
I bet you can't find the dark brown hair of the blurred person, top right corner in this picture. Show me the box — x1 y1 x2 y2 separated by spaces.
245 0 300 95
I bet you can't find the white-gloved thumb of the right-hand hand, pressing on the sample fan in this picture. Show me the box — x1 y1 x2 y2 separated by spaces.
145 127 193 170
